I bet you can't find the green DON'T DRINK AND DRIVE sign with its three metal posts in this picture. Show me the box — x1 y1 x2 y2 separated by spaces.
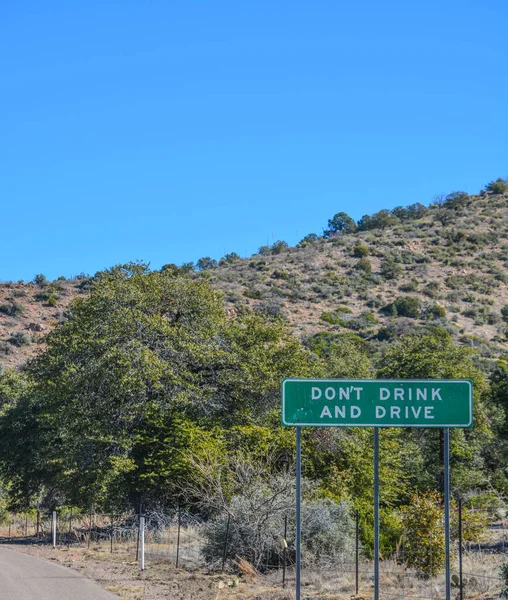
281 379 473 600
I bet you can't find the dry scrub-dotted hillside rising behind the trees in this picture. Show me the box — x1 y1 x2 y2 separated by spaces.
0 184 508 366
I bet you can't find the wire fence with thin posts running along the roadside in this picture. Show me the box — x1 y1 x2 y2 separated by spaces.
0 507 508 600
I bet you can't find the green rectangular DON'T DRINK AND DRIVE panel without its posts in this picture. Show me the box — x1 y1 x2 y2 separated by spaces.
282 379 473 427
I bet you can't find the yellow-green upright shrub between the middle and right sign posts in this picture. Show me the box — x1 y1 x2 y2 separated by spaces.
402 491 445 579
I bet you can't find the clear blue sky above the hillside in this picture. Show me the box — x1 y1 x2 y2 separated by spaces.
0 0 508 280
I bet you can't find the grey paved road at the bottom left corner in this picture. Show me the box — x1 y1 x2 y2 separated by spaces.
0 547 118 600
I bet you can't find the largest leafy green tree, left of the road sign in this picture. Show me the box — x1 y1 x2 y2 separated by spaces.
0 264 307 505
